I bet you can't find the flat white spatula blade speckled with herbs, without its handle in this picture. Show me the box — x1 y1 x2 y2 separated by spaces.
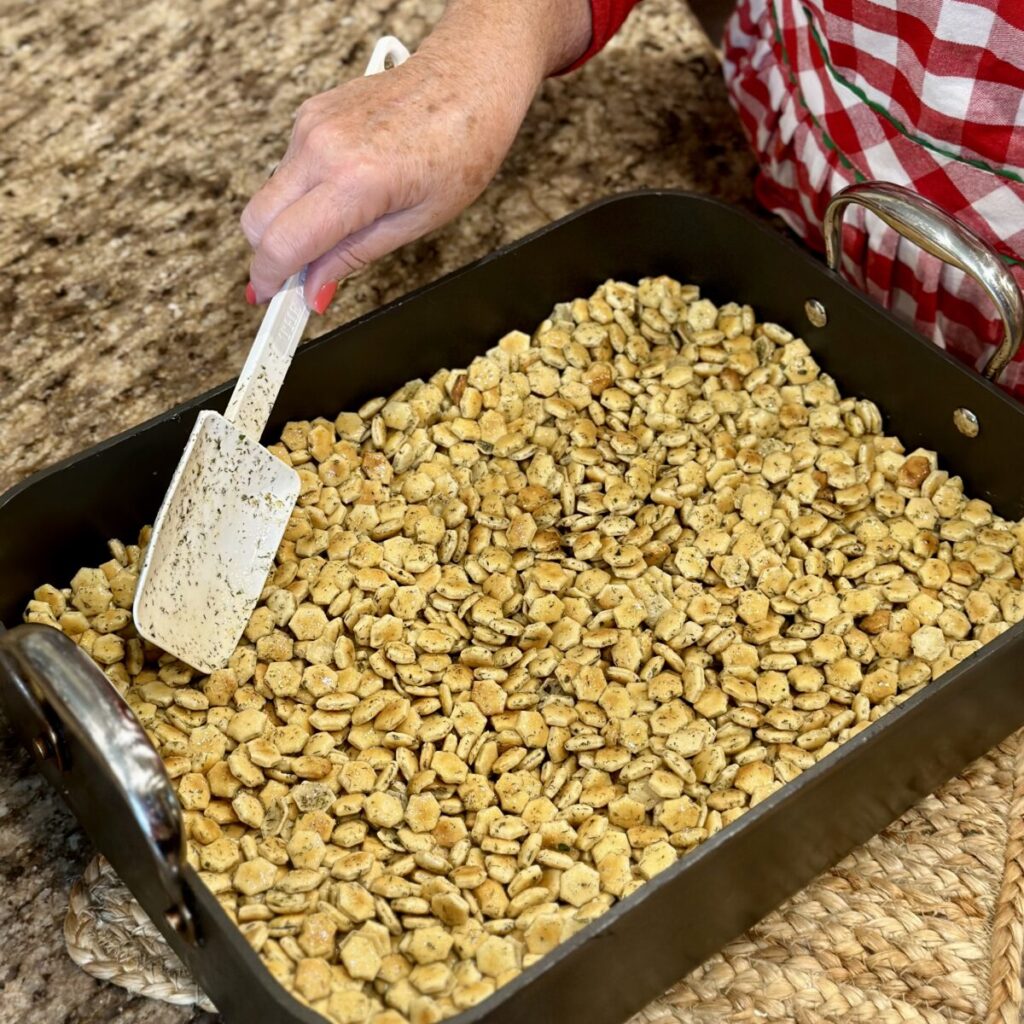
133 410 299 672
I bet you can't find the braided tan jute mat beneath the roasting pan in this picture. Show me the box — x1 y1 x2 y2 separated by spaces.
65 731 1024 1024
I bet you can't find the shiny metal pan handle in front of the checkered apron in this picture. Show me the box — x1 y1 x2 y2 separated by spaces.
822 181 1024 381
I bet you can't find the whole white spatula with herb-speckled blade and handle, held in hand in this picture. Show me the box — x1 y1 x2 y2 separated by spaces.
133 36 409 672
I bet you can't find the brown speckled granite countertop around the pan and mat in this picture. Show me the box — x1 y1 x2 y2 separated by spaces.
0 0 753 1024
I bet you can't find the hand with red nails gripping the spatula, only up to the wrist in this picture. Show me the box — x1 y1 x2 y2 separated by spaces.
242 55 532 311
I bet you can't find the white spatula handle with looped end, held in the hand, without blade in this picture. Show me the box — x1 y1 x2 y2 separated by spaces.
224 36 409 443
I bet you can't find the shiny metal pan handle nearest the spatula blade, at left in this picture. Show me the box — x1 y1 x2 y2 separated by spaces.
0 625 197 945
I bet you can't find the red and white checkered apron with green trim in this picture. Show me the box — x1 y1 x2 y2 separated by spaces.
724 0 1024 397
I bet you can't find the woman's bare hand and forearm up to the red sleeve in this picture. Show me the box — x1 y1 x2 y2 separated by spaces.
242 0 590 312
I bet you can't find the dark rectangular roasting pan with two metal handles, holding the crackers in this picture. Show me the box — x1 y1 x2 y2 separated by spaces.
0 185 1024 1024
